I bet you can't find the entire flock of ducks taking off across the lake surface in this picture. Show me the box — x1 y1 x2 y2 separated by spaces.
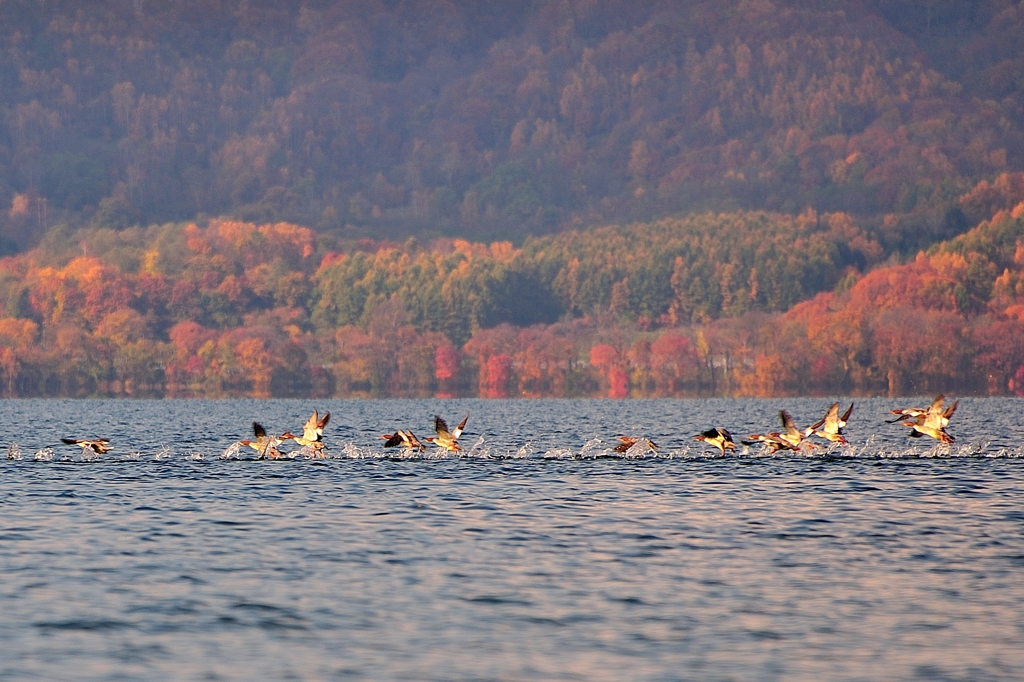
51 395 959 460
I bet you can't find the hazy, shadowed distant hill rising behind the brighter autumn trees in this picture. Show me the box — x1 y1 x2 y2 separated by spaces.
0 0 1024 254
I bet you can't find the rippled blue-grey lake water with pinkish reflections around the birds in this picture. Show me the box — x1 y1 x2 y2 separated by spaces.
0 397 1024 680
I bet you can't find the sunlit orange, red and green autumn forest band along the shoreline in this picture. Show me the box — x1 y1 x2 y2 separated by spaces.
0 174 1024 397
